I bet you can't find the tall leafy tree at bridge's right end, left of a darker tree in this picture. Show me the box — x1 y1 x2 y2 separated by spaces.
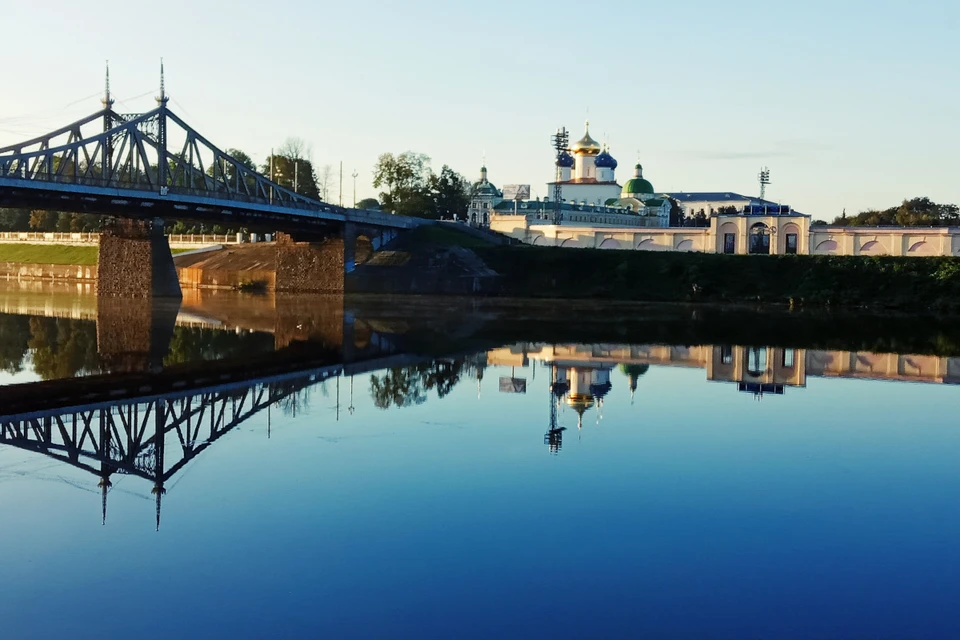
373 151 431 217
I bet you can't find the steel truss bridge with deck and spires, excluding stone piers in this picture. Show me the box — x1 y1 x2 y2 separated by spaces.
0 85 428 231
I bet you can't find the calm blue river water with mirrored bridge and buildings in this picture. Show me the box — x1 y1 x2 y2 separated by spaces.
0 291 960 639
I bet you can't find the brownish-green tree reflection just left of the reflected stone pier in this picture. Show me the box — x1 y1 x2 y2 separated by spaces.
28 318 101 380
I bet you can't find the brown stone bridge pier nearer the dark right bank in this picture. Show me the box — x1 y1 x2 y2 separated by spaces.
276 224 357 293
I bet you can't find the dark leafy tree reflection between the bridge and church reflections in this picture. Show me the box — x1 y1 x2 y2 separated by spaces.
370 359 464 409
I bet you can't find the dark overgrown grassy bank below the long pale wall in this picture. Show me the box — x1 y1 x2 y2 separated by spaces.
474 246 960 311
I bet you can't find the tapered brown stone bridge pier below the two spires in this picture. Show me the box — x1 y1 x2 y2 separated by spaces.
97 219 183 298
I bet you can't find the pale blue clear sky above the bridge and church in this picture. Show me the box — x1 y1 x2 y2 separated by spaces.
0 0 960 219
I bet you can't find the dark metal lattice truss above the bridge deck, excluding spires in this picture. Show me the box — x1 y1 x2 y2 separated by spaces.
0 104 332 210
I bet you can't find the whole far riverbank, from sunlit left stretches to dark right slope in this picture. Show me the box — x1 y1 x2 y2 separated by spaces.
0 232 960 313
